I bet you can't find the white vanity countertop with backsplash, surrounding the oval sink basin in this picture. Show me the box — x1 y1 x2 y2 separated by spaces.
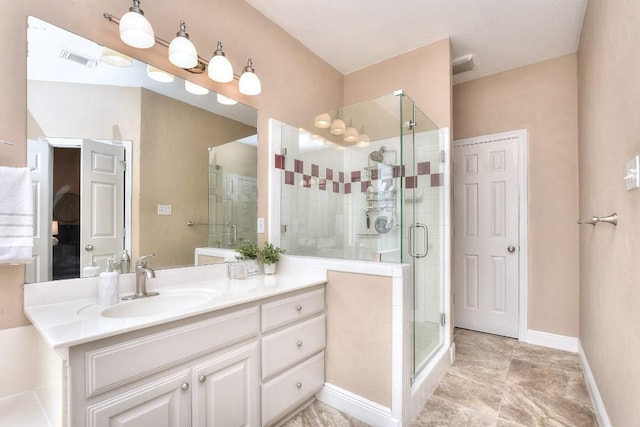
24 264 327 349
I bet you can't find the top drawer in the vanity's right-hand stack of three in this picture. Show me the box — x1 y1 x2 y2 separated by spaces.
262 289 324 332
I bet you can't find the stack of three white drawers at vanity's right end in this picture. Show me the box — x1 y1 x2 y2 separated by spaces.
261 288 326 426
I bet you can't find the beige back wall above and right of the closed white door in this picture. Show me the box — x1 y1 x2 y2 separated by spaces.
453 55 580 337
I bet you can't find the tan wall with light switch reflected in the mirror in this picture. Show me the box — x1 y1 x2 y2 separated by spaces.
139 90 256 267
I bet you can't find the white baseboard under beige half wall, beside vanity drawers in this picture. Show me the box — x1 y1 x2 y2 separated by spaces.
316 383 400 427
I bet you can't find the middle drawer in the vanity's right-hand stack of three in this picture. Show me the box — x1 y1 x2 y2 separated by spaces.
262 314 326 379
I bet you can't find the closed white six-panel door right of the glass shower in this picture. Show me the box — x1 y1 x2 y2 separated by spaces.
454 138 519 338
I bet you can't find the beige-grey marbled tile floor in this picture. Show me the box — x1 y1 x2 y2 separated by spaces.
285 329 598 427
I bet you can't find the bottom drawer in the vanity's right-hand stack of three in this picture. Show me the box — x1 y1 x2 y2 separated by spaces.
262 352 324 425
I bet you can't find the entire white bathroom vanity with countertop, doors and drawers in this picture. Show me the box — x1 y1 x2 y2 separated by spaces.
25 264 326 427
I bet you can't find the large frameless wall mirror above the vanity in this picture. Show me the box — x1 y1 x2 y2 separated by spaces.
26 17 257 283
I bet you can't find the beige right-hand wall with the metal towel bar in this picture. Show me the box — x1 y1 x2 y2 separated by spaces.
578 0 640 426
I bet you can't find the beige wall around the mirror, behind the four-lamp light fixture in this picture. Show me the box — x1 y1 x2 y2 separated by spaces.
0 0 343 328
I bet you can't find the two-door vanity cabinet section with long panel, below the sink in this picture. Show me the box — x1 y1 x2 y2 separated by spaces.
69 306 260 427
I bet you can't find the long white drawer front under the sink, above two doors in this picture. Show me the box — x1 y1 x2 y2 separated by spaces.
85 307 258 397
